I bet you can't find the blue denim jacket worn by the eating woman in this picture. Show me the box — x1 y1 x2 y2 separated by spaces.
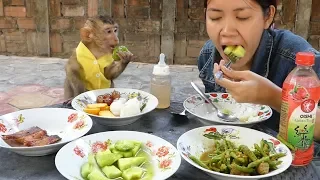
198 29 320 130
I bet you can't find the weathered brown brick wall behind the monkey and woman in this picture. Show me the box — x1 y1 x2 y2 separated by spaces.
0 0 320 64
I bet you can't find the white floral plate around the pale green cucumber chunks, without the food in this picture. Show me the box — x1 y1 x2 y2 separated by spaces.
55 131 181 180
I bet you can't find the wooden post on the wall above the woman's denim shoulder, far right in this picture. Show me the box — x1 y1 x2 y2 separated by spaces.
295 0 312 39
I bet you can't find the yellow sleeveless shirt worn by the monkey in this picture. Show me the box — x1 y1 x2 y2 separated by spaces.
76 42 113 90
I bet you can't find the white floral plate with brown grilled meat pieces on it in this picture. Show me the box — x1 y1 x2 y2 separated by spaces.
0 108 92 156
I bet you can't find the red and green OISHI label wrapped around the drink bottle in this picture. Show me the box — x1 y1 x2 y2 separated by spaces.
279 83 319 165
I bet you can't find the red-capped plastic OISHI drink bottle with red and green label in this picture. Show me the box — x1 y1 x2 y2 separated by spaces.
279 52 320 166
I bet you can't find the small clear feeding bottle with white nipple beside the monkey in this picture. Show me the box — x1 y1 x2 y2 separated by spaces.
150 53 171 109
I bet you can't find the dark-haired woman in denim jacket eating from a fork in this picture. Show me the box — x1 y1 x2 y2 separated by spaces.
198 0 320 139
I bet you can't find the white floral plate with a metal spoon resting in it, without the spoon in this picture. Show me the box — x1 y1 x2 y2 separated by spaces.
183 93 272 126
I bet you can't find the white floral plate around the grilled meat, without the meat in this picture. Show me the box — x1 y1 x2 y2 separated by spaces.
0 108 92 156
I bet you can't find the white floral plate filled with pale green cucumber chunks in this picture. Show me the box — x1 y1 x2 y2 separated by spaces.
55 131 181 180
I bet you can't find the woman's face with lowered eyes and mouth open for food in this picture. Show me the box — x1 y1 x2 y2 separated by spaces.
206 0 274 69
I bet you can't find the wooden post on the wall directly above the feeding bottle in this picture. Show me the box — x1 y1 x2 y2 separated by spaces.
161 0 176 64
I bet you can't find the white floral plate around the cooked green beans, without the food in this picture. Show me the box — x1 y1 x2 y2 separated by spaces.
177 125 292 180
